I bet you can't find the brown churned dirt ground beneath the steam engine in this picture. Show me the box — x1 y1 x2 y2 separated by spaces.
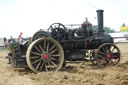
0 43 128 85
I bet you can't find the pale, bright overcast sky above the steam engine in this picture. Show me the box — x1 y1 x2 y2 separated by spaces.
0 0 128 38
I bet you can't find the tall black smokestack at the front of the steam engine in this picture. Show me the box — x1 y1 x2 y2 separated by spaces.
96 10 104 36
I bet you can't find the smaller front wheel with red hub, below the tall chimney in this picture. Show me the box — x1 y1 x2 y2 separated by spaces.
96 43 121 67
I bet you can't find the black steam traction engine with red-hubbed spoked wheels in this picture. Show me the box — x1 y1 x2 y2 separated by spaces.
8 10 120 73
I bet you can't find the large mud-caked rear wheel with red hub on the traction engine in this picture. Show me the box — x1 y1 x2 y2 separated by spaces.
26 38 64 73
